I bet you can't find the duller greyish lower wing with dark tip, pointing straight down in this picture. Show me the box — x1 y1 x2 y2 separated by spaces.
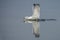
32 21 40 37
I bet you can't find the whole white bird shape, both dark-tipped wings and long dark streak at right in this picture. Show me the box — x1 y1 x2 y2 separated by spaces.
24 4 56 37
